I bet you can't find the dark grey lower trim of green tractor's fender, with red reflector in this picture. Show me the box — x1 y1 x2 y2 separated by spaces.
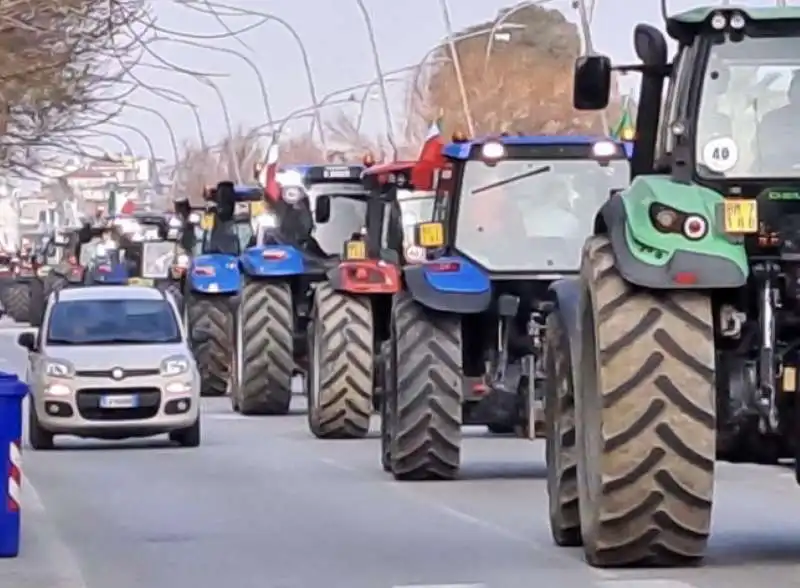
599 194 747 289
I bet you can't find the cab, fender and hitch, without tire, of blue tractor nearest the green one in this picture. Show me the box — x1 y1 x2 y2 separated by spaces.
418 136 630 436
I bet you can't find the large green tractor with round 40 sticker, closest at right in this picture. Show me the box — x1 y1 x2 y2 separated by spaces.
544 7 800 567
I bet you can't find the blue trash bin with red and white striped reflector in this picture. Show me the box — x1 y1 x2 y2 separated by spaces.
0 372 28 557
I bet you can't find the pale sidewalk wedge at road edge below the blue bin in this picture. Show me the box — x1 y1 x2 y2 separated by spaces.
0 479 87 588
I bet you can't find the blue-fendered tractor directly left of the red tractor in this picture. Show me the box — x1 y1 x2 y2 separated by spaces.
231 165 367 415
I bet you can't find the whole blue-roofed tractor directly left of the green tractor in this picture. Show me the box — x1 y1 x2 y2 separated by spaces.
381 136 629 480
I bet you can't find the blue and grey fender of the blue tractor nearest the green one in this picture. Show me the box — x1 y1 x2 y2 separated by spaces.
403 257 492 314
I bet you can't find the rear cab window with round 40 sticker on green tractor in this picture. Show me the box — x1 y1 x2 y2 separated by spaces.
696 36 800 178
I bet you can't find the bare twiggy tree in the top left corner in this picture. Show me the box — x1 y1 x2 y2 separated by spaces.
0 0 145 173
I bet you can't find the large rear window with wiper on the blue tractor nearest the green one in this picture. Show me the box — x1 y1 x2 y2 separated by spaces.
455 159 630 272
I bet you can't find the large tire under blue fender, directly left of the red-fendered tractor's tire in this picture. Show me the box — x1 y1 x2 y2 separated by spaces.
232 280 294 415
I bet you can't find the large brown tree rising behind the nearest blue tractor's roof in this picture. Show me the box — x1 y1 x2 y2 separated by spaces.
406 5 620 144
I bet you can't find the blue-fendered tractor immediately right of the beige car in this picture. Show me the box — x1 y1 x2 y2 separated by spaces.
181 182 264 396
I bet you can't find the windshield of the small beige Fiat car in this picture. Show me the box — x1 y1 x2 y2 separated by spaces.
47 299 181 345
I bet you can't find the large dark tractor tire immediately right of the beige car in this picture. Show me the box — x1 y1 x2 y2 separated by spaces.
186 292 233 396
